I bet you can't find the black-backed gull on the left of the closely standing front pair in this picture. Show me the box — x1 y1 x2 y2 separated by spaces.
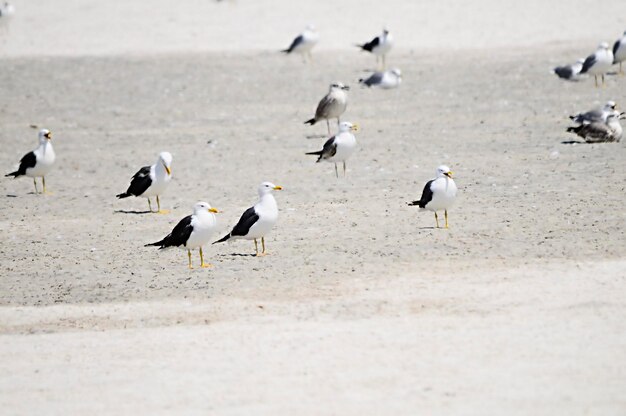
145 202 219 269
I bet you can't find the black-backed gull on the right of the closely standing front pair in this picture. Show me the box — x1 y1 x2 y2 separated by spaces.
213 182 283 256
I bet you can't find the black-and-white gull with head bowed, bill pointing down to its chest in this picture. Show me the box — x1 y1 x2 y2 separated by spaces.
116 152 172 214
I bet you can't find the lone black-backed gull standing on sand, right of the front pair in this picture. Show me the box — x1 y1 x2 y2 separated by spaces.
409 165 456 228
